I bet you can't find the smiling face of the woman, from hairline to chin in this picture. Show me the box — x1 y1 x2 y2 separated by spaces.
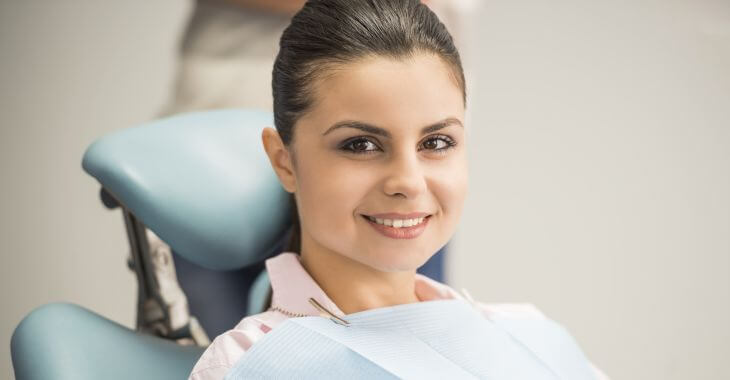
268 54 468 272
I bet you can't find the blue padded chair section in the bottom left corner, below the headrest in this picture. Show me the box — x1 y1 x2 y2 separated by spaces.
10 303 204 380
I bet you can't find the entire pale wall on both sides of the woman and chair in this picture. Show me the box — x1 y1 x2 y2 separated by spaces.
0 0 730 380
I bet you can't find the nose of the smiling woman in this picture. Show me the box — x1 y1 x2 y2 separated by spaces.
383 148 426 199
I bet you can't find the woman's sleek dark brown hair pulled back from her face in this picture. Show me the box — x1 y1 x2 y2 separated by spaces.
272 0 466 252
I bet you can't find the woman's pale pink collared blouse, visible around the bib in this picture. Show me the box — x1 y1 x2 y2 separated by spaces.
188 252 608 380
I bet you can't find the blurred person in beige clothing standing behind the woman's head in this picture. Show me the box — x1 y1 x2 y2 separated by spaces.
162 0 479 116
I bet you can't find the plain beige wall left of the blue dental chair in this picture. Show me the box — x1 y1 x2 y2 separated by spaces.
0 0 189 379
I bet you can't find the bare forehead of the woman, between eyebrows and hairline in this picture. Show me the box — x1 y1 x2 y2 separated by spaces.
301 54 464 134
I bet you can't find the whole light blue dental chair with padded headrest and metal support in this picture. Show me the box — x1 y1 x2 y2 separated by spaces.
11 110 445 380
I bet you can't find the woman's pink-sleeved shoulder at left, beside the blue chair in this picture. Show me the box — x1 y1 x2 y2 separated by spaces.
188 311 286 380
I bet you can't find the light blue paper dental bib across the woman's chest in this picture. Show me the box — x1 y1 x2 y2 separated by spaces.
225 300 595 380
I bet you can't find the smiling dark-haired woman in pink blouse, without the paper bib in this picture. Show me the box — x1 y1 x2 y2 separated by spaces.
190 0 605 380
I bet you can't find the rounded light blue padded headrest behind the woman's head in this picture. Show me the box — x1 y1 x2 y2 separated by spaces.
83 110 291 270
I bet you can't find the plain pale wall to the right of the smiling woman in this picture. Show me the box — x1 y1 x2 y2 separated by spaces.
449 1 730 380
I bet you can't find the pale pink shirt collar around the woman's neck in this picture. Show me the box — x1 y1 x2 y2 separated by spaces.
266 252 463 315
